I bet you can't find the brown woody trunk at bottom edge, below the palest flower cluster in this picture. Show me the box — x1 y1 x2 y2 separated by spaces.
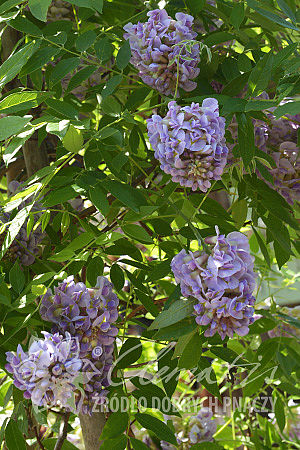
79 412 106 450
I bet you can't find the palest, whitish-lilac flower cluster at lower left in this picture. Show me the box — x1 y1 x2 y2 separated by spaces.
5 331 82 409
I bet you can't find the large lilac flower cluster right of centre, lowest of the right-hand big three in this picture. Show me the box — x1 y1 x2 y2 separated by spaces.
171 227 255 339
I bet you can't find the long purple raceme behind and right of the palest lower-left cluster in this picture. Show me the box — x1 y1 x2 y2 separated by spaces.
40 276 119 413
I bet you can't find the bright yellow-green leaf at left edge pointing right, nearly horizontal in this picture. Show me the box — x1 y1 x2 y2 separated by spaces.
0 91 51 114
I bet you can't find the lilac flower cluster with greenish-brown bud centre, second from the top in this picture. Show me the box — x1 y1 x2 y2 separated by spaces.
147 98 228 192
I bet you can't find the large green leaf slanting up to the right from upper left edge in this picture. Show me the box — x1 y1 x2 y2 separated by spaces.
0 42 40 88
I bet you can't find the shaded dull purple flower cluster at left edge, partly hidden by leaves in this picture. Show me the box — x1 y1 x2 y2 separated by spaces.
0 181 44 266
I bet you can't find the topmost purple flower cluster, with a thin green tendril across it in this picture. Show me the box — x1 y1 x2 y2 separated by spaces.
124 9 200 95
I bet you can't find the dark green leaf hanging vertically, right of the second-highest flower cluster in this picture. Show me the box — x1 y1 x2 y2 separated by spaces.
236 113 255 167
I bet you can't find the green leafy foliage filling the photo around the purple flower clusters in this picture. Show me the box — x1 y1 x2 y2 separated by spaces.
0 0 300 450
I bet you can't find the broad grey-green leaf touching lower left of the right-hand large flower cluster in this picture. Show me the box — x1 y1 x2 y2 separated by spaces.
149 299 194 330
